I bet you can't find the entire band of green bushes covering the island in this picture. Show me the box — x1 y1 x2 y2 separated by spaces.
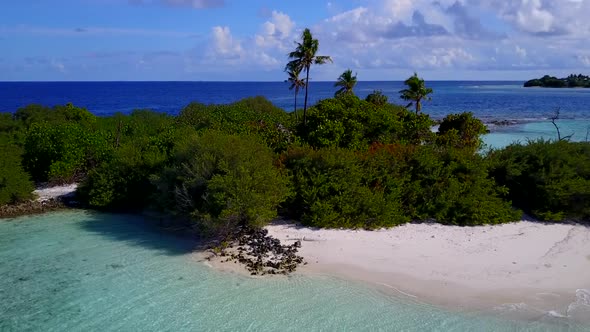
0 92 590 233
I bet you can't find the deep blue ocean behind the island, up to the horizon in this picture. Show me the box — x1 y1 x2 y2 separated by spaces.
0 81 590 122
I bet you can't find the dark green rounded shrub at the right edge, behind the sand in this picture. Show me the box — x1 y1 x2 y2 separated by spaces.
490 140 590 221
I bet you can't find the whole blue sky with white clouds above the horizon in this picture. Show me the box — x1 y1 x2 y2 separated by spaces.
0 0 590 81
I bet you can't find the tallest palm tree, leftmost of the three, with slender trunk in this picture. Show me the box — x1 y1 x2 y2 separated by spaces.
285 28 332 125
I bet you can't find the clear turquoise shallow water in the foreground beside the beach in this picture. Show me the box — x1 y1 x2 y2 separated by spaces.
0 211 590 331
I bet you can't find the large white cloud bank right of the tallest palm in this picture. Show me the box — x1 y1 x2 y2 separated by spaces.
306 0 590 79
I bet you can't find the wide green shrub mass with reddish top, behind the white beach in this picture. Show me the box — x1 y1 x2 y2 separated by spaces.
283 144 520 229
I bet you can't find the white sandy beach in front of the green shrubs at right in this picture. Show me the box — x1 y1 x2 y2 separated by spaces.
206 221 590 321
